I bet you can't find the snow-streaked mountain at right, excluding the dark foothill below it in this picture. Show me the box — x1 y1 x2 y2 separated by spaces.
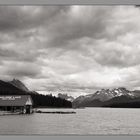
73 87 135 106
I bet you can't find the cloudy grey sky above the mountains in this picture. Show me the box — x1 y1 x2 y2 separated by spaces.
0 6 140 95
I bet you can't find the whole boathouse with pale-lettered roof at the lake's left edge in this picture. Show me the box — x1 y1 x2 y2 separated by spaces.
0 95 33 114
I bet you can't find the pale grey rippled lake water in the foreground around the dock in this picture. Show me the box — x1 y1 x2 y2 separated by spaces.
0 108 140 135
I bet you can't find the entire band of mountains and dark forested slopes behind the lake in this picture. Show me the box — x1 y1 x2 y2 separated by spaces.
0 79 140 108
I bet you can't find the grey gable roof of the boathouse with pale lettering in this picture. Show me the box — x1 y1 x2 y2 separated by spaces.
0 95 33 106
